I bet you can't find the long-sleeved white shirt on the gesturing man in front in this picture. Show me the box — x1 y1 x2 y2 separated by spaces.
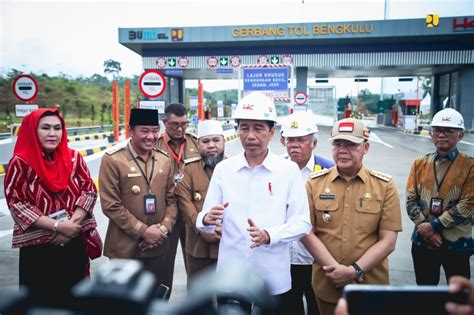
196 151 311 295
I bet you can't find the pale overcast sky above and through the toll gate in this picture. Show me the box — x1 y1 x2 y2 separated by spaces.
0 0 474 94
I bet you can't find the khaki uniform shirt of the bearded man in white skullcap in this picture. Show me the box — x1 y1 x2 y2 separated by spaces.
175 157 219 259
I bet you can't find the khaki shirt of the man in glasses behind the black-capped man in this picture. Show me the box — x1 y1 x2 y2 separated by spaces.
156 131 201 174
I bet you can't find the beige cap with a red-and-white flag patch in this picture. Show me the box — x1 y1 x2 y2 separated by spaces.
329 118 370 143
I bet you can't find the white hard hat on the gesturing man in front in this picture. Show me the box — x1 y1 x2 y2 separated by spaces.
234 92 277 122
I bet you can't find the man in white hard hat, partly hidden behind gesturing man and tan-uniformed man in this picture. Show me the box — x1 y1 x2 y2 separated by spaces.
281 111 334 315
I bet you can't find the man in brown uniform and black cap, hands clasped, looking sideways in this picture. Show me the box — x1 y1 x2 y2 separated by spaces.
99 108 177 298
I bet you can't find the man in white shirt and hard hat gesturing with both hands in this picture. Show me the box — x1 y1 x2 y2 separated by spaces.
196 92 311 314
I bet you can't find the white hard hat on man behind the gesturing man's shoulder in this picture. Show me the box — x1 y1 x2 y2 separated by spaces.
281 111 318 137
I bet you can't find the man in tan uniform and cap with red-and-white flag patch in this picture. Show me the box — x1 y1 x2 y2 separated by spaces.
302 118 402 315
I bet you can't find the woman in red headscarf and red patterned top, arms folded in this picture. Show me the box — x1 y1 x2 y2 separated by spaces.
4 108 101 307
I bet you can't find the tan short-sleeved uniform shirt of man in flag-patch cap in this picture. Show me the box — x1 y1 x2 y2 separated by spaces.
306 166 402 303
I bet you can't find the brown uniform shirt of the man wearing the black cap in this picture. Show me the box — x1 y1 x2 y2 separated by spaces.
99 142 177 258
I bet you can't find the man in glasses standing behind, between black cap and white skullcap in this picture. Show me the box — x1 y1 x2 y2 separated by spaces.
156 103 199 284
